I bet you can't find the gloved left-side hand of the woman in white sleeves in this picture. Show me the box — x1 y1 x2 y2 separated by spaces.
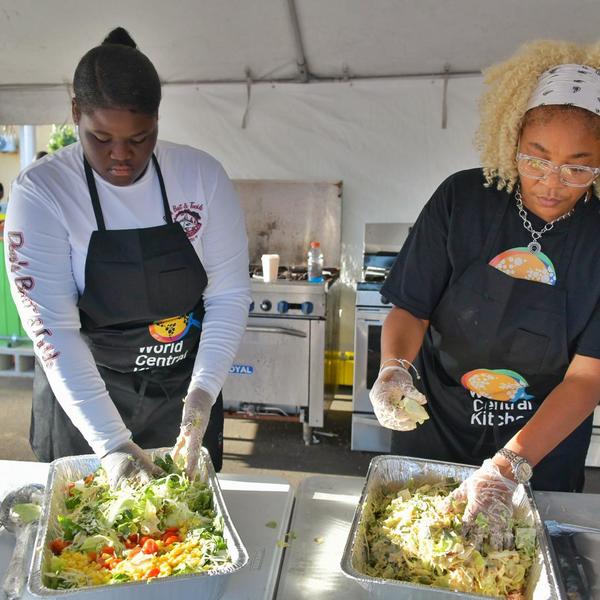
100 440 164 490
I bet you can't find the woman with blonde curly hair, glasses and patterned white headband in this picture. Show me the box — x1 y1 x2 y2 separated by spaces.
371 41 600 546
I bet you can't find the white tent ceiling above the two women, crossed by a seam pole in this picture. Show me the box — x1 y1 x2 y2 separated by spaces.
0 0 600 89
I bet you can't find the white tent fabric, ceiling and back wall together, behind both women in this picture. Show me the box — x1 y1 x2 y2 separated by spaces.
0 0 600 349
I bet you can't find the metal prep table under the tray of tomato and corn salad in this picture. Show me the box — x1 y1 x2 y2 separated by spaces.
0 460 294 600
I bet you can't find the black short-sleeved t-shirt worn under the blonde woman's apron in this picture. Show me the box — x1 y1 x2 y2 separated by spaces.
382 169 600 359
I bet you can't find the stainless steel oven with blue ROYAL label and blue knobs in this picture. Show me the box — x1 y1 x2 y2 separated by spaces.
223 280 326 443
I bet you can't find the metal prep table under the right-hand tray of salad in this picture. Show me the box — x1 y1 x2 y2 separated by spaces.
276 475 600 600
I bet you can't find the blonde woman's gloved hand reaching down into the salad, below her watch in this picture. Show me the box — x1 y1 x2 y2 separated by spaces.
448 458 517 550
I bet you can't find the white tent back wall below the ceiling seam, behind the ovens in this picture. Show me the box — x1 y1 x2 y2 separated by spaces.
160 77 481 350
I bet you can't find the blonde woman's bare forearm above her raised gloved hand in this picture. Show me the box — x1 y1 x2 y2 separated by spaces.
381 307 429 364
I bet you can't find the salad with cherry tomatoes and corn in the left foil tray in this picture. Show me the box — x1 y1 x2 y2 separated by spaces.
44 455 231 589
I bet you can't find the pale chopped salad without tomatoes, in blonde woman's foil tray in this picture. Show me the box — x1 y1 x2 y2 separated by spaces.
364 480 536 600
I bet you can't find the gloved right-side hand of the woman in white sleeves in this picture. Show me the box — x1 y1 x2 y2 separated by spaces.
172 388 213 479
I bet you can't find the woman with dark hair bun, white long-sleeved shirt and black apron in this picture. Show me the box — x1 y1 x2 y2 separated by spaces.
5 28 250 487
